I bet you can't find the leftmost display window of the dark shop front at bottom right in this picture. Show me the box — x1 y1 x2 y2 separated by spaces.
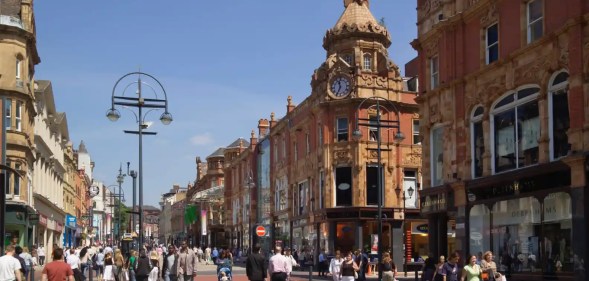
469 205 492 256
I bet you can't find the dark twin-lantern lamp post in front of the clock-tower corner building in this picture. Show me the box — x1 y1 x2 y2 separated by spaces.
352 96 405 280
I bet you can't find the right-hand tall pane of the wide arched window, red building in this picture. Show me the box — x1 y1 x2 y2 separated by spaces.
517 101 540 168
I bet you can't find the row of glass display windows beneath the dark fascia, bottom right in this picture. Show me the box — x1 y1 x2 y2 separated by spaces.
470 192 573 272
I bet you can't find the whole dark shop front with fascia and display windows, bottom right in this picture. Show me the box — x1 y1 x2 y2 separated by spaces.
466 162 587 280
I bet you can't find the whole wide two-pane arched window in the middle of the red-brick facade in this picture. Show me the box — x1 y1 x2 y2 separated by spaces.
491 86 540 173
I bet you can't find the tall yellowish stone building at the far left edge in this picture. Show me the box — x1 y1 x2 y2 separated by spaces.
0 0 41 246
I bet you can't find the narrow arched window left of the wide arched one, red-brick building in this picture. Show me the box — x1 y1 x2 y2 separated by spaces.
470 106 485 178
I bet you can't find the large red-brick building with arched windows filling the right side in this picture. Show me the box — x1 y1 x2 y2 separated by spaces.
412 0 589 280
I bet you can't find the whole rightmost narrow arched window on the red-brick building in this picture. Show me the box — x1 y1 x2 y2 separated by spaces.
548 71 570 160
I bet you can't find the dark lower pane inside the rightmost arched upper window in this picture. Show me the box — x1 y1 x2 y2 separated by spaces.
552 90 570 159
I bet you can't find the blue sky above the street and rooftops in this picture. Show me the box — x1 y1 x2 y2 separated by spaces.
35 0 417 206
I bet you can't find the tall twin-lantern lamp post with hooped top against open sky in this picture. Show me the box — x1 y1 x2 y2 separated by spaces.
106 72 173 247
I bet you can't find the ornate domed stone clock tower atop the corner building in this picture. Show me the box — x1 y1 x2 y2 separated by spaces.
311 0 403 100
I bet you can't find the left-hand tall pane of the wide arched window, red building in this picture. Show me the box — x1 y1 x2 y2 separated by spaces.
494 109 517 172
